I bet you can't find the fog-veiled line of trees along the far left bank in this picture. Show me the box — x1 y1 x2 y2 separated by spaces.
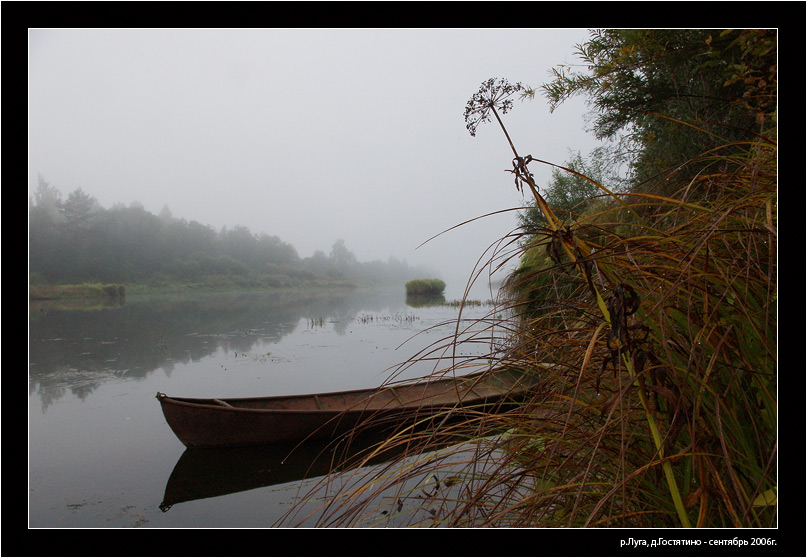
28 176 433 287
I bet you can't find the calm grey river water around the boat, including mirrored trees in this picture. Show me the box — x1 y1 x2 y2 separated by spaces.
28 289 502 528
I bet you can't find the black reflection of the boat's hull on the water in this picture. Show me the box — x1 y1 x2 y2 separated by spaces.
160 435 434 512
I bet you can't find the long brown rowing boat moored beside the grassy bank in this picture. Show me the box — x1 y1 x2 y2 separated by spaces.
157 370 536 448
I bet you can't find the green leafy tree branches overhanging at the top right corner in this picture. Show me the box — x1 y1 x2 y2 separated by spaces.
542 29 777 183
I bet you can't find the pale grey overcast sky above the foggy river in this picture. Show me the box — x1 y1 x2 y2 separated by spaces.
28 29 596 302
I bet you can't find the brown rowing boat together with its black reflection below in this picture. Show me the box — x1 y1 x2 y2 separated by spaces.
157 369 538 511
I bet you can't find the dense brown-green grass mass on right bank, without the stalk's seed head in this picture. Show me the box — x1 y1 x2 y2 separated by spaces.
490 132 777 527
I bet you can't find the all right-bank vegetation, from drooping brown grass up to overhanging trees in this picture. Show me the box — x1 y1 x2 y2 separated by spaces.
302 29 779 528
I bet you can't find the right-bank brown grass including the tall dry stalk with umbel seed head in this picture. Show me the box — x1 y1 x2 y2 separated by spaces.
290 83 778 527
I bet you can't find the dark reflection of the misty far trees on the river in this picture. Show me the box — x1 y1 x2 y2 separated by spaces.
28 291 410 409
